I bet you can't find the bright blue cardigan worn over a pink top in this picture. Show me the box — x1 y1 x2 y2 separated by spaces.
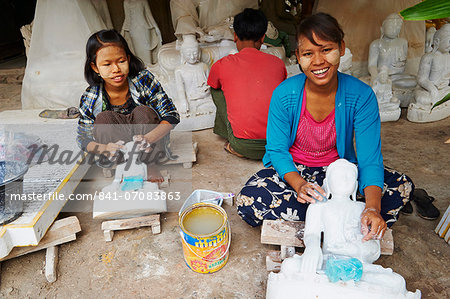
263 72 384 194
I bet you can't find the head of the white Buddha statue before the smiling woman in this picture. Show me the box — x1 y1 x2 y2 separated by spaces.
324 159 358 200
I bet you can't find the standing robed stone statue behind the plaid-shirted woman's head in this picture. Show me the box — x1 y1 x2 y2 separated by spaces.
121 0 162 65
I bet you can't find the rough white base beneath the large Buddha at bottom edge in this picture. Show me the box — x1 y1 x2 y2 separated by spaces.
266 272 421 299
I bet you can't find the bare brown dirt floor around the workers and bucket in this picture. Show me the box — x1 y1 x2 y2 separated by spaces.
0 56 450 298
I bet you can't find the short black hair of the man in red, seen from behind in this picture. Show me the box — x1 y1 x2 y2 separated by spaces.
233 8 267 42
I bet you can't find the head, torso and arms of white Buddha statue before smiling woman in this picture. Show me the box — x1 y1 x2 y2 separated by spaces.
301 159 380 272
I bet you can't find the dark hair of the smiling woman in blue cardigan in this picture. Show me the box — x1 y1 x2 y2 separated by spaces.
297 12 344 46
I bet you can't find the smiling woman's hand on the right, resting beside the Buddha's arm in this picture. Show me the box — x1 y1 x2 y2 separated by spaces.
361 208 387 241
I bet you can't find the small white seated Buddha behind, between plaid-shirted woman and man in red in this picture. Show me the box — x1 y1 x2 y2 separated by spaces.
175 37 215 114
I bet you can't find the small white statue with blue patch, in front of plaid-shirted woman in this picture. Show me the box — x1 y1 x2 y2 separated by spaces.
93 141 167 219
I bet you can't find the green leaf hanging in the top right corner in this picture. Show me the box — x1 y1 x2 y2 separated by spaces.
400 0 450 21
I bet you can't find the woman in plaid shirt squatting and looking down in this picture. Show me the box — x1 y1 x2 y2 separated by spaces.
77 30 180 181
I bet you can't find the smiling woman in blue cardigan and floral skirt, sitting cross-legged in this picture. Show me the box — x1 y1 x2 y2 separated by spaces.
237 13 414 244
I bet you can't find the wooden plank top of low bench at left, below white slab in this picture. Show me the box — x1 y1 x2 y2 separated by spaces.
0 216 81 261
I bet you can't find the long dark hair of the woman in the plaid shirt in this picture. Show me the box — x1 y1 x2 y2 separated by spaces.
84 29 145 86
